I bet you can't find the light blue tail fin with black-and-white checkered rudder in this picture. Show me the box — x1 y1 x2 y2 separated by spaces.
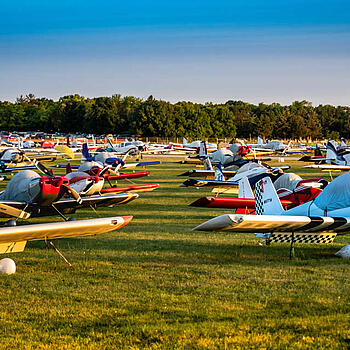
255 177 284 215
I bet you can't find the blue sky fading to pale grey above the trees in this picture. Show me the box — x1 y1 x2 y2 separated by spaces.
0 0 350 105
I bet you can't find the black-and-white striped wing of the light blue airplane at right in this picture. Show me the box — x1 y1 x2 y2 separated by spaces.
193 214 350 233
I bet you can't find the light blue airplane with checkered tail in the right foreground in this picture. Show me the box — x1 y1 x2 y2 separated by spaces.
194 173 350 257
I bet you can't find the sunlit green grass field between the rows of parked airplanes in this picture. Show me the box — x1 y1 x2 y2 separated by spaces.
0 159 350 349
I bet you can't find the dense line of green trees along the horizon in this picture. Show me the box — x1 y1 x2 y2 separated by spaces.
0 94 350 139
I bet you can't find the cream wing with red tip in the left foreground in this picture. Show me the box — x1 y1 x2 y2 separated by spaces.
0 216 132 253
